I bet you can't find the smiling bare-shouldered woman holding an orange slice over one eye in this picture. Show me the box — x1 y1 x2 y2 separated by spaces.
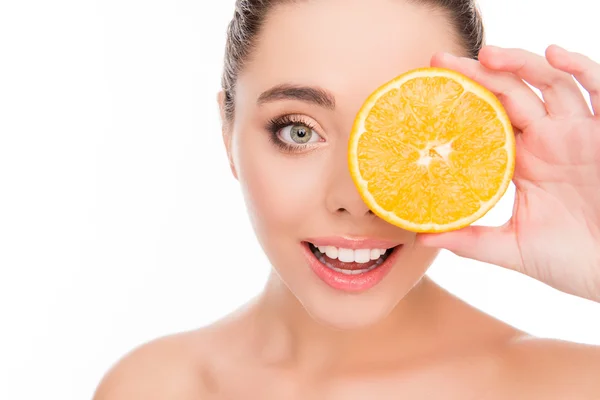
96 0 600 400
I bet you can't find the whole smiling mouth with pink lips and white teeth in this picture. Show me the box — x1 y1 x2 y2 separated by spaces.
302 238 403 292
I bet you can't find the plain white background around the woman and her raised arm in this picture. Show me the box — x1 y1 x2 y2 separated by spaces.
0 0 600 400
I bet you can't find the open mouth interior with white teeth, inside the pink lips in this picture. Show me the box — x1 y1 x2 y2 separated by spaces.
306 242 401 275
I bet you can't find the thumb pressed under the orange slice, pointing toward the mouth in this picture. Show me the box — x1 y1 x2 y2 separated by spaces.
417 224 521 271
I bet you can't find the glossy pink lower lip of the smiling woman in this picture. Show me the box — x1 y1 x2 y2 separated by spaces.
302 241 403 293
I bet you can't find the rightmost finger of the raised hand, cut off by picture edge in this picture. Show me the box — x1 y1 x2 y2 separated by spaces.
546 45 600 115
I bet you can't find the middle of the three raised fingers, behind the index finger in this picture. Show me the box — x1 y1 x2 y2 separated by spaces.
479 46 590 117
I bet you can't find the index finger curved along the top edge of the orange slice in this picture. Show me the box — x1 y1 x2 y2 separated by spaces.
431 53 548 130
